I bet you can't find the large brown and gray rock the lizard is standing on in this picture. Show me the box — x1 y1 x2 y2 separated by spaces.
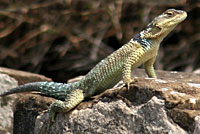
0 70 200 134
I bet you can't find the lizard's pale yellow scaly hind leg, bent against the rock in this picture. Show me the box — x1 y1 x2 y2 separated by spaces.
48 89 84 122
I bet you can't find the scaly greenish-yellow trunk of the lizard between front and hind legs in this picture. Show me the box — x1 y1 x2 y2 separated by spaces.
80 42 145 96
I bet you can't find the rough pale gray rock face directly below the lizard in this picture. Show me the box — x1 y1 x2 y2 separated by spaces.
35 97 187 134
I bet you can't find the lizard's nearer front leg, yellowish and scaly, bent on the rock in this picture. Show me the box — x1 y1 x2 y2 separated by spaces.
122 44 145 89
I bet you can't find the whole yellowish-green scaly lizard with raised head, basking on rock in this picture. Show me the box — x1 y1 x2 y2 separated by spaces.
0 9 187 121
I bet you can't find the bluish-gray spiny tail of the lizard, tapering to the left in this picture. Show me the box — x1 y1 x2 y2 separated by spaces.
0 82 79 100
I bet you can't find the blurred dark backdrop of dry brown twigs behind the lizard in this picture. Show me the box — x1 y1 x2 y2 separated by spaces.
0 0 200 82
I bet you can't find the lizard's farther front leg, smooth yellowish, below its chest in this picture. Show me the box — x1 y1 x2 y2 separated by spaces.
144 56 157 78
